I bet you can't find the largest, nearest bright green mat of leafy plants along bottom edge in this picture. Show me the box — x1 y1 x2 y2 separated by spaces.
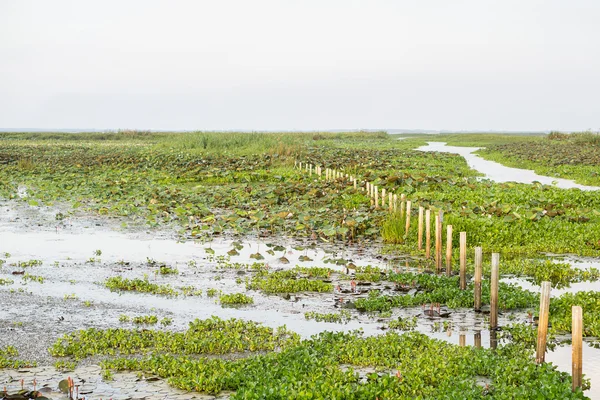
89 332 585 399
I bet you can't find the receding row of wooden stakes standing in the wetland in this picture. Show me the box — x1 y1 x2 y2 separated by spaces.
296 162 583 391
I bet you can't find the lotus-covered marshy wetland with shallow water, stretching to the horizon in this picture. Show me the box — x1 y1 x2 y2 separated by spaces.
0 131 600 399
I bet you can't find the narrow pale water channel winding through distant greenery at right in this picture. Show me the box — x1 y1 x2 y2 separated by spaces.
417 142 600 190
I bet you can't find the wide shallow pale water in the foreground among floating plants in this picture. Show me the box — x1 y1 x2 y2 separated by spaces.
0 202 600 398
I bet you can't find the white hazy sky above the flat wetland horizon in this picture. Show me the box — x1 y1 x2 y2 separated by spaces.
0 0 600 130
